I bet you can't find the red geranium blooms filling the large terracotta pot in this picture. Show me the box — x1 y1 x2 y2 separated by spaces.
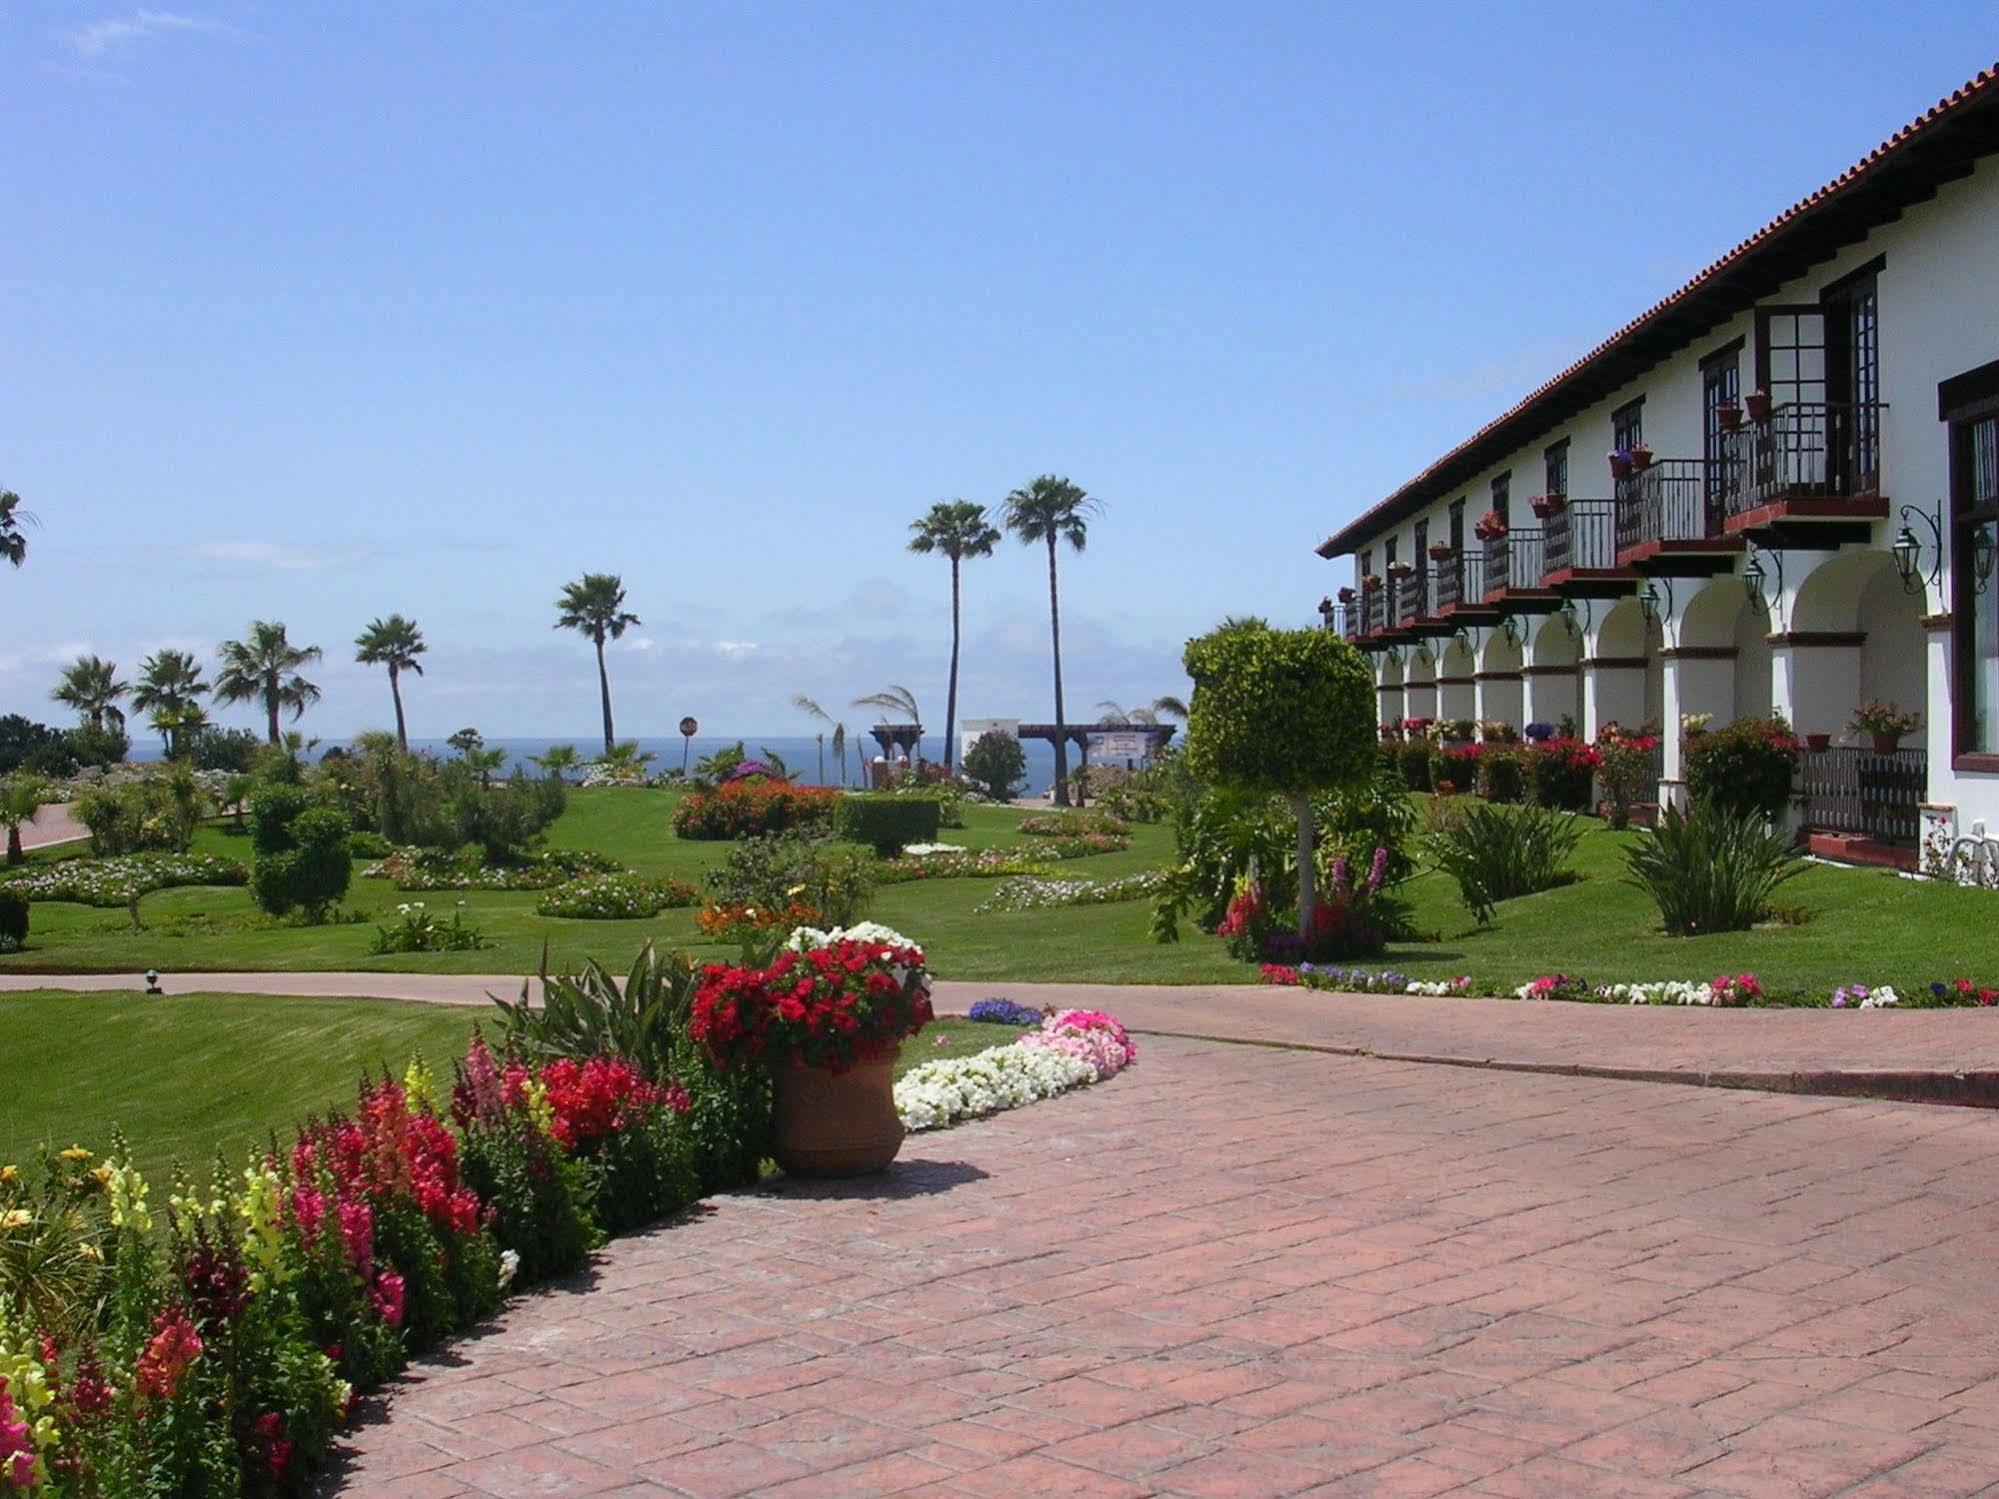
688 937 932 1071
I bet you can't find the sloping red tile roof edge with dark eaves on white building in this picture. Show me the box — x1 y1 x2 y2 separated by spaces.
1317 62 1999 558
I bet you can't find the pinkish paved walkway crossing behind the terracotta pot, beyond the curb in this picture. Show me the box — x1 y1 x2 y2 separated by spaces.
0 973 1999 1105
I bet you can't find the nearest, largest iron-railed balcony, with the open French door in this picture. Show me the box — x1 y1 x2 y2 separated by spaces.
1719 402 1887 546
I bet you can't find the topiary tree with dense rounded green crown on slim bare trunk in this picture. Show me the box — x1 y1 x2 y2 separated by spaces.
1183 620 1375 931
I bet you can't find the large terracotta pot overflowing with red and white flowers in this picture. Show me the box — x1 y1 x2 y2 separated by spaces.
688 927 932 1177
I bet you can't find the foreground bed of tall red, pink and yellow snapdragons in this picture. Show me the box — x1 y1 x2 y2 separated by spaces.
0 1015 760 1495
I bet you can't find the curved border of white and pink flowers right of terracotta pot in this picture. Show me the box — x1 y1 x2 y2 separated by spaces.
896 1015 1137 1131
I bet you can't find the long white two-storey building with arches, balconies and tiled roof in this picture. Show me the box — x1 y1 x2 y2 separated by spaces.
1319 72 1999 863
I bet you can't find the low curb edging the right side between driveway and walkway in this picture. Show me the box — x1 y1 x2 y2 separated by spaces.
1131 1025 1999 1109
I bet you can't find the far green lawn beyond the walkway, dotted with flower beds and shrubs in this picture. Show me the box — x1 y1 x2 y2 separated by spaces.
0 789 1999 993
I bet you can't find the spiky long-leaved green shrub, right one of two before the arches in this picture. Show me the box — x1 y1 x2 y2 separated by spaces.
1625 801 1805 937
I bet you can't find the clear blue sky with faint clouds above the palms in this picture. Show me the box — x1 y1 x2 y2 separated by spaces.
0 0 1999 738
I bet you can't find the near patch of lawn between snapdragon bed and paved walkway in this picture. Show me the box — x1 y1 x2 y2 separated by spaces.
0 989 1019 1181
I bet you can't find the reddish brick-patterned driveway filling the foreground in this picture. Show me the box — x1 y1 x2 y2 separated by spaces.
338 1039 1999 1495
